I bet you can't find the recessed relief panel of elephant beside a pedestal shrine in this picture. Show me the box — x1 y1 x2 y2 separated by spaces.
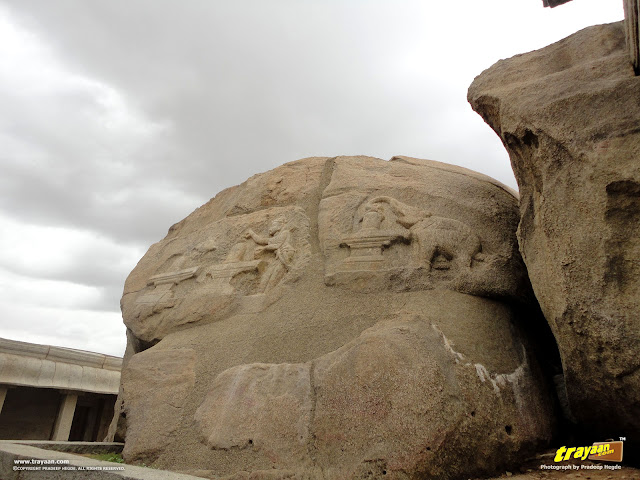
325 196 485 290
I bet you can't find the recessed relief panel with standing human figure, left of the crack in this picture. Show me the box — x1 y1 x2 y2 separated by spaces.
135 209 308 322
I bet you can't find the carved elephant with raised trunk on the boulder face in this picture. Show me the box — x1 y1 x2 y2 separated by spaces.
370 196 482 269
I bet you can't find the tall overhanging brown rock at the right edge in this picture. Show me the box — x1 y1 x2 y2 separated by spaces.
468 23 640 438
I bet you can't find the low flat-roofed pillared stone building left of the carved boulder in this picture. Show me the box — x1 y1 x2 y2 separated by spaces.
0 338 122 441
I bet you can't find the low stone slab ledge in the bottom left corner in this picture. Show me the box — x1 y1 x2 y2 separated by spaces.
0 442 201 480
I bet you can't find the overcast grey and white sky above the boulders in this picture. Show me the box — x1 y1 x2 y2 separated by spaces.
0 0 623 355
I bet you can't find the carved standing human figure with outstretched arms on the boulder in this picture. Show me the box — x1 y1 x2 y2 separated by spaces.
245 216 296 292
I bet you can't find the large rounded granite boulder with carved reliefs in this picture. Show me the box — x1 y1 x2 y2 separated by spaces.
115 157 554 479
